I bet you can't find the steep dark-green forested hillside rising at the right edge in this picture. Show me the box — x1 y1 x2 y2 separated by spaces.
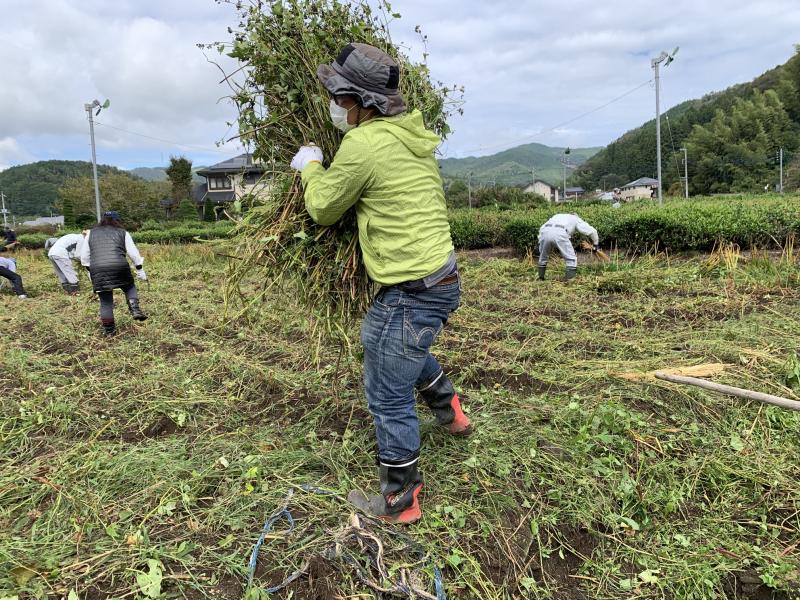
571 48 800 194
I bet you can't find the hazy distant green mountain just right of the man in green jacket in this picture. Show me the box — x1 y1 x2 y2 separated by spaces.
439 144 600 186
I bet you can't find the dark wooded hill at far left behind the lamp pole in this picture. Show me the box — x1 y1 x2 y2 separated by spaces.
0 160 124 217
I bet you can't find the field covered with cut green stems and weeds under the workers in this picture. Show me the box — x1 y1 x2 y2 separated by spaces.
0 245 800 599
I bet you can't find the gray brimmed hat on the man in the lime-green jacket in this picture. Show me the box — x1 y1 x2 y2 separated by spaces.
317 43 406 117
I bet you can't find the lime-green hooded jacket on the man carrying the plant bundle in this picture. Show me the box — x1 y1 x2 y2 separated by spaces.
302 110 453 285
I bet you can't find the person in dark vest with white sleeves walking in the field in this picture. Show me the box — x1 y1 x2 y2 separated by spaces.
80 210 147 336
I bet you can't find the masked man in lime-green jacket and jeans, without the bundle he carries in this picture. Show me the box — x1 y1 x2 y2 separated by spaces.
291 43 470 523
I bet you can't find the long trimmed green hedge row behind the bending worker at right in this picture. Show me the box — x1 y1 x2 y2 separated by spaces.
451 196 800 252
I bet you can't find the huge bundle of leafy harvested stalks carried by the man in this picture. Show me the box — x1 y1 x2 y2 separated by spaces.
212 0 463 339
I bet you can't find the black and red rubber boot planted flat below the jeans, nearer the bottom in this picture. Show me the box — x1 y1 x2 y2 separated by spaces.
347 457 422 523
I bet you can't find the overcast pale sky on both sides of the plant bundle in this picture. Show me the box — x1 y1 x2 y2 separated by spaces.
0 0 800 169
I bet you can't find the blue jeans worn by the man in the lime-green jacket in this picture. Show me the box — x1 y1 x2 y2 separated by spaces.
361 278 461 464
